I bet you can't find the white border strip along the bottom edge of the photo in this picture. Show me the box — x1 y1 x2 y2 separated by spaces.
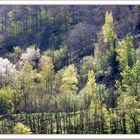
0 134 140 140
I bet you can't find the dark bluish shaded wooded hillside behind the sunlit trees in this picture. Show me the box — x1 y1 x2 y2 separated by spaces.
0 5 140 56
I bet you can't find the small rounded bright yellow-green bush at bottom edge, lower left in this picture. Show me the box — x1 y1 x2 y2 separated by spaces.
13 123 32 134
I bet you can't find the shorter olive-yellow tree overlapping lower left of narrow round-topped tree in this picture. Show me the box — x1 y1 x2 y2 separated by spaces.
28 73 49 112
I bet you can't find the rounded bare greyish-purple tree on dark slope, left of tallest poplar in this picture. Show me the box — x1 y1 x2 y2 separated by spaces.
68 22 91 63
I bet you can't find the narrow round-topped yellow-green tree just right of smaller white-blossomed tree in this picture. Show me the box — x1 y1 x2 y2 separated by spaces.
38 54 55 111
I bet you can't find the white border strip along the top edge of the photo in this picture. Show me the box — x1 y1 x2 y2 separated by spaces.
0 0 140 5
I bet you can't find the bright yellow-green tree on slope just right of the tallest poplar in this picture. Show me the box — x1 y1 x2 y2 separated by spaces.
116 35 135 71
